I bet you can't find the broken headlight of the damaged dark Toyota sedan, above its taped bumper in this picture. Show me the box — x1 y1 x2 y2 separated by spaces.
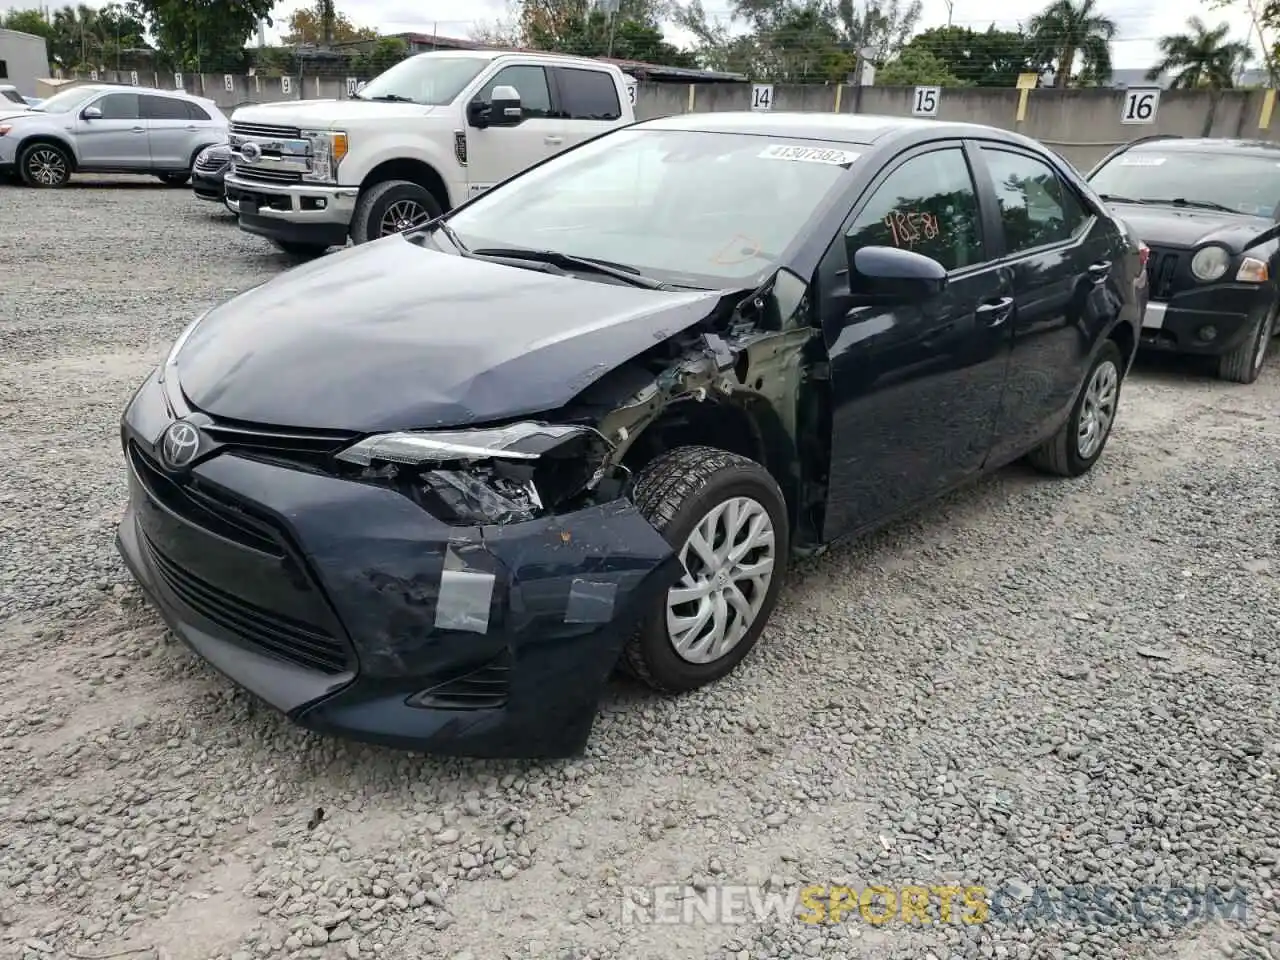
337 421 609 525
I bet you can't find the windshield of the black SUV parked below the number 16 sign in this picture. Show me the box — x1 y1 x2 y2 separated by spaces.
1089 147 1280 219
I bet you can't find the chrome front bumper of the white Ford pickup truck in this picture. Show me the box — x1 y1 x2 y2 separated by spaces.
225 173 360 247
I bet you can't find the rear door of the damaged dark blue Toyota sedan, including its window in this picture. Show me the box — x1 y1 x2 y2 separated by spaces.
977 142 1123 465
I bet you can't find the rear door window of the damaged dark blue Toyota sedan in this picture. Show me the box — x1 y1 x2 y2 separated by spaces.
982 147 1088 253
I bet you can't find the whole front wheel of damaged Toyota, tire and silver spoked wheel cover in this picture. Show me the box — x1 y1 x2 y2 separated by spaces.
622 447 790 692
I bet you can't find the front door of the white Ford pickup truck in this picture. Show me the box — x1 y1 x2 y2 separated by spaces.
466 64 564 198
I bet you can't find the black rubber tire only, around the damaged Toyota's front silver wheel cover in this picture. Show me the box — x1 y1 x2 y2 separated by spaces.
622 447 790 692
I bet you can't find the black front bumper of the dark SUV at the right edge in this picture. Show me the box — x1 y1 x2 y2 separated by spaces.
1142 283 1276 356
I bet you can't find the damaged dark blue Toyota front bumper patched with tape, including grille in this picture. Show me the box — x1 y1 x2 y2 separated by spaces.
116 375 680 758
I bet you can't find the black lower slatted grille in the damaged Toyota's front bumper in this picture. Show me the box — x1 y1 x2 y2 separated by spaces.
147 540 351 676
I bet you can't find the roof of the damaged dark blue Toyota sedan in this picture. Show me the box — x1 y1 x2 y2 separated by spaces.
636 110 1043 150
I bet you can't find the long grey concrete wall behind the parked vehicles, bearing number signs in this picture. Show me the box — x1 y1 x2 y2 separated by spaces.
67 70 1280 170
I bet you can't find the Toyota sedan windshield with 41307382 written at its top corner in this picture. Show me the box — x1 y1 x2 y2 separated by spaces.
449 129 858 287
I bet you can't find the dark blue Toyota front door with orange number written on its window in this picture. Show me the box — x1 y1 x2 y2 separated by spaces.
819 141 1012 539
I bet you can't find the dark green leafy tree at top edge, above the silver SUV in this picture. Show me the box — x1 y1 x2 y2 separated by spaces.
138 0 275 72
